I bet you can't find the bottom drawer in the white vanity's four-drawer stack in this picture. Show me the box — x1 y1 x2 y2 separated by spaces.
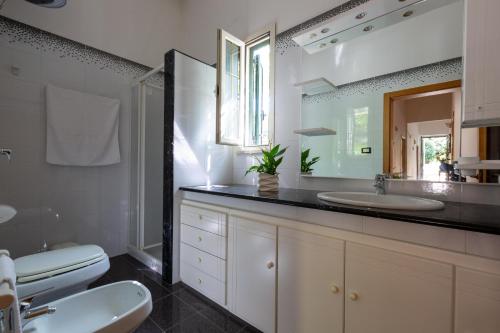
181 262 226 306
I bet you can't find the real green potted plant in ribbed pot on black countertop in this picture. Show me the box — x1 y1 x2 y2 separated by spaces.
245 145 286 192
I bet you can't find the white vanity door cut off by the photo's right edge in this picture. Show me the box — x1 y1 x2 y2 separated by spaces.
455 267 500 333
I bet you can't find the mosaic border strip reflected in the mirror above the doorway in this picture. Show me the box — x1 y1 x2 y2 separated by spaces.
302 58 463 104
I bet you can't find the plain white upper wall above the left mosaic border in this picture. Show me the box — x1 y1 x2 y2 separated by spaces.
0 0 181 67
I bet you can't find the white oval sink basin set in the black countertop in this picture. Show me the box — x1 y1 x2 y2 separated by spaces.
318 192 444 210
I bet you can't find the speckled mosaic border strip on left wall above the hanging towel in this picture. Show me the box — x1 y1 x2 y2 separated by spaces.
0 15 164 87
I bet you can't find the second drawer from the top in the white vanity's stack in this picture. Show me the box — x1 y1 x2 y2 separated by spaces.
181 224 226 259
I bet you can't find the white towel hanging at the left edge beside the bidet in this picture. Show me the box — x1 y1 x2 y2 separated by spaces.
0 250 22 333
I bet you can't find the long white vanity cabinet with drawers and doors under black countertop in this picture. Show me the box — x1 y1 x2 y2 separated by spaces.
181 200 500 333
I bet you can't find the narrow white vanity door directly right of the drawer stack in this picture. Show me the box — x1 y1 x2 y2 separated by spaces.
228 217 277 333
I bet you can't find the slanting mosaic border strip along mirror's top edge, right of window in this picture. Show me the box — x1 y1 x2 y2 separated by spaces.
276 0 372 55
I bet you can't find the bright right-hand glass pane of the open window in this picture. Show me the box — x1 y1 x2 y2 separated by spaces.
245 36 271 146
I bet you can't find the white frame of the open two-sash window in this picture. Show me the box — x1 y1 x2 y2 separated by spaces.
216 24 276 154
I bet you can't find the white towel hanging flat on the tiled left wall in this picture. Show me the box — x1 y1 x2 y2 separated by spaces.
46 84 120 166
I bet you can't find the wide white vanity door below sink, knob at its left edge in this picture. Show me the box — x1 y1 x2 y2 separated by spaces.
345 242 453 333
